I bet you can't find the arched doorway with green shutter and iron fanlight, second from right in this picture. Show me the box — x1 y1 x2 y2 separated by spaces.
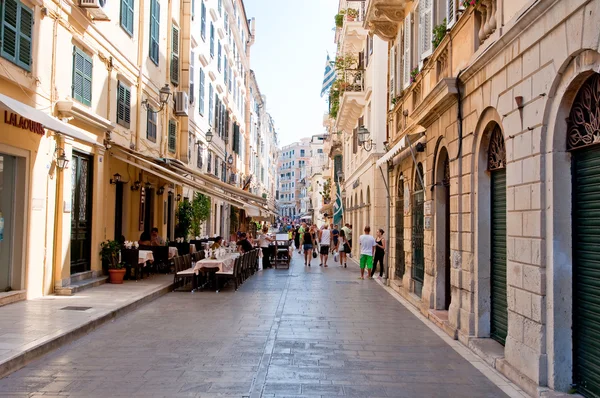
487 125 508 345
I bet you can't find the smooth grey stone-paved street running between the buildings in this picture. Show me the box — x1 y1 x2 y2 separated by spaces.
0 254 505 398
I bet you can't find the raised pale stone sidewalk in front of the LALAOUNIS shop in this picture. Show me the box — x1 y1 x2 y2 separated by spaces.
0 275 173 380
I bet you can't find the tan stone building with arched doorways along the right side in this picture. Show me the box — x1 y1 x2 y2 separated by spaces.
363 0 600 397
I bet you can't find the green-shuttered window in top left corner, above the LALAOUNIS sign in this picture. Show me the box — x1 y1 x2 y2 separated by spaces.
1 0 33 71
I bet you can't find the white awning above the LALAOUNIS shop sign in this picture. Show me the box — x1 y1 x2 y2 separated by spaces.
0 94 96 144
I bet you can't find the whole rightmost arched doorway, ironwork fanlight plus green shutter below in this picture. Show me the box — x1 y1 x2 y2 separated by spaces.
567 74 600 397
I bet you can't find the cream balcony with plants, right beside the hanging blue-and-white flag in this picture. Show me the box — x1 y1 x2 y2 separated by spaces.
331 69 366 132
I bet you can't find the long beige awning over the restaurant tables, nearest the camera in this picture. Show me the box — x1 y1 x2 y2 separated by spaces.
111 147 245 207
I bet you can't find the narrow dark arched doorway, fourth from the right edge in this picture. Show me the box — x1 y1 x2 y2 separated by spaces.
412 163 425 297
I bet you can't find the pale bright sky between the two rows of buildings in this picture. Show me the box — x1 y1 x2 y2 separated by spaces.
244 0 338 147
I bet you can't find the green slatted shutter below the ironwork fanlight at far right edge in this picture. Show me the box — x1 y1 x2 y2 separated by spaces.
572 146 600 397
